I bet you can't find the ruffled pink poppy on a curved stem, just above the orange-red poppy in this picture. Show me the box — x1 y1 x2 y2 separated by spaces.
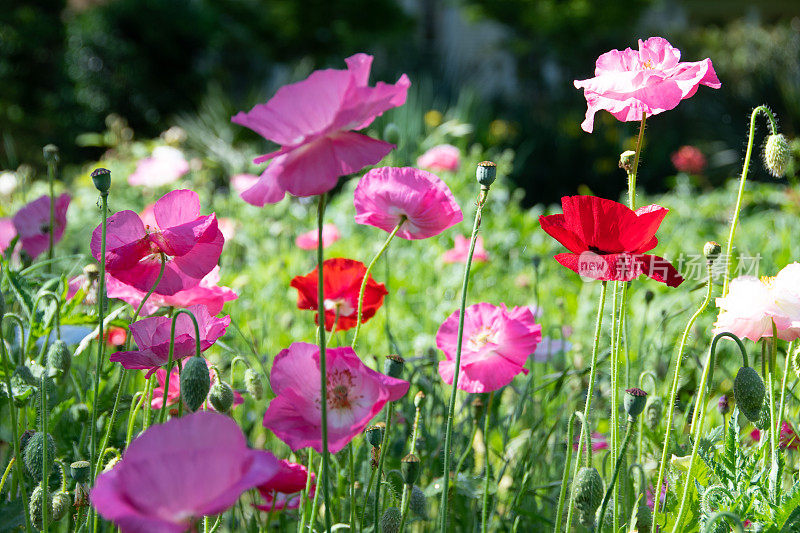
353 167 464 239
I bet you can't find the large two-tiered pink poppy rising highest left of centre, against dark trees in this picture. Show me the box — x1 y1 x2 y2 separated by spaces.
231 54 411 206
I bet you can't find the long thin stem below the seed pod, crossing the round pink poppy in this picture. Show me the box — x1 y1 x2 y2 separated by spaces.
439 187 489 533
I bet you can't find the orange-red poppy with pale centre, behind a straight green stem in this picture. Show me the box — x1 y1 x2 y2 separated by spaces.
291 257 388 331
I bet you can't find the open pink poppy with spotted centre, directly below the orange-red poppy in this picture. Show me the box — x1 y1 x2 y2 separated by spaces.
263 342 409 453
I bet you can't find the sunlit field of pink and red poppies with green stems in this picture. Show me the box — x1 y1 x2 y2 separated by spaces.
0 37 800 533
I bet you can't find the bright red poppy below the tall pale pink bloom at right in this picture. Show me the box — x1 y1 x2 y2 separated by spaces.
539 196 683 287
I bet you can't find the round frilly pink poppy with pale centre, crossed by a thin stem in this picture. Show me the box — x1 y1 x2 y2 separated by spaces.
436 303 542 393
